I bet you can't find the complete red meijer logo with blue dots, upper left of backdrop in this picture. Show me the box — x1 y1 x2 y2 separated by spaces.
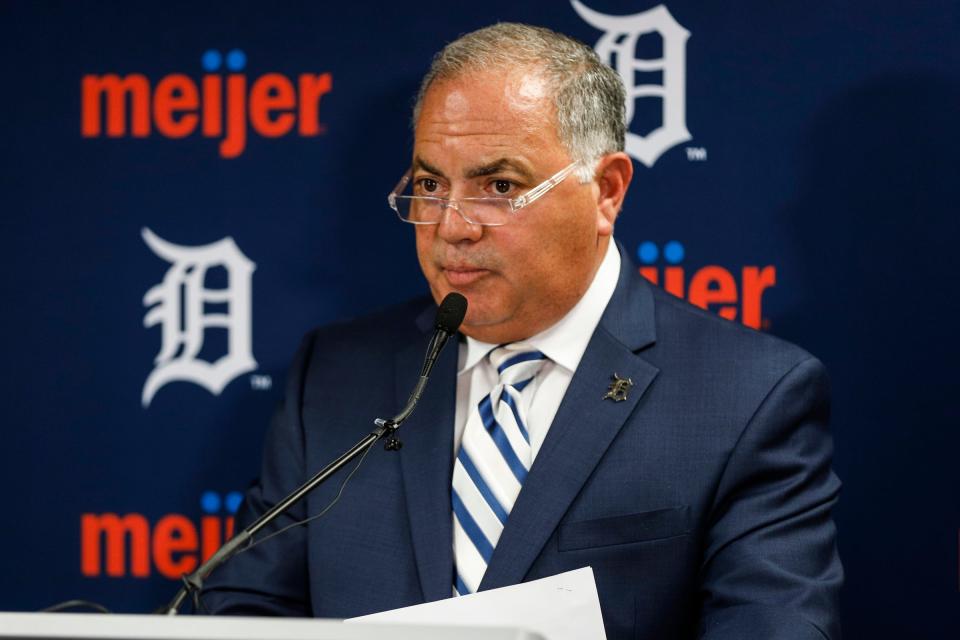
80 49 333 158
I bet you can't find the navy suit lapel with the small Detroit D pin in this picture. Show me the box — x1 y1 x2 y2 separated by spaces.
480 251 659 589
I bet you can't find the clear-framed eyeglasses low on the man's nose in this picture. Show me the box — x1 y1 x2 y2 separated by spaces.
387 162 580 227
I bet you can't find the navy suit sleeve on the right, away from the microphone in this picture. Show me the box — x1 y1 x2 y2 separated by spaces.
700 358 843 640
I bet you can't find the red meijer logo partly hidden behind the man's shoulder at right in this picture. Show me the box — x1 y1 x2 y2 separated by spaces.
637 241 777 329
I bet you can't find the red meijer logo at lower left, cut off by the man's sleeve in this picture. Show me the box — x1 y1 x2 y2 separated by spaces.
80 491 243 579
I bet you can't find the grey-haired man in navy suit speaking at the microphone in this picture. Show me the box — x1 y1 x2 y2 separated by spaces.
204 24 842 638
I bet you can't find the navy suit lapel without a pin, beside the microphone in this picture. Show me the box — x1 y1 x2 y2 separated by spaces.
396 308 457 602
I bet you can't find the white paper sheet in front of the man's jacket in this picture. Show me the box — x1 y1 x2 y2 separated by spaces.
347 567 607 640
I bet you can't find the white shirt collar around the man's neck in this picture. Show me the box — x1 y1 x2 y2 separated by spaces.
459 238 620 373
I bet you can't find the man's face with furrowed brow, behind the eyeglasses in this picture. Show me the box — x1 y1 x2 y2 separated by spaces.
412 69 613 343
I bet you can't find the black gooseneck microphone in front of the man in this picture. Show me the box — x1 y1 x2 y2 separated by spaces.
163 293 467 615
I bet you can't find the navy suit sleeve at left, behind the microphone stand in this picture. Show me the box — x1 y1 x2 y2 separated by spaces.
200 333 315 616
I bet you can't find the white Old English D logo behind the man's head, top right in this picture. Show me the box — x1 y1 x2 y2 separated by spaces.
571 0 690 167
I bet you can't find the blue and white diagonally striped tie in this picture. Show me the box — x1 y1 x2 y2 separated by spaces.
451 342 546 595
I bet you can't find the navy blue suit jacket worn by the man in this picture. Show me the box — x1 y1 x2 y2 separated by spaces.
204 254 843 639
